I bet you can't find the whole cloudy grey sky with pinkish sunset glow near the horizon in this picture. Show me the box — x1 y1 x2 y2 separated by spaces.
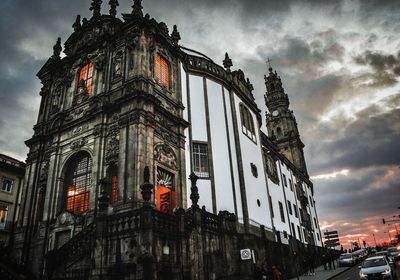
0 0 400 248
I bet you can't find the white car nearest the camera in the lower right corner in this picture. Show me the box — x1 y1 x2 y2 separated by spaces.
359 256 394 280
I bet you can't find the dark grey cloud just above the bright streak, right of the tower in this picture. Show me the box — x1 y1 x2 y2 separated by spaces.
309 101 400 173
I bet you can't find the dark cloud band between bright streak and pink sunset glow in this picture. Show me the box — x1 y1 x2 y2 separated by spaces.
316 166 400 219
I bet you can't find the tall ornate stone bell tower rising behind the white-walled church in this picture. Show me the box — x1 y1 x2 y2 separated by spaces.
264 66 308 176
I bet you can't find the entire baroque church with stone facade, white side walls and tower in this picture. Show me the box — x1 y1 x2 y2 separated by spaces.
9 0 322 279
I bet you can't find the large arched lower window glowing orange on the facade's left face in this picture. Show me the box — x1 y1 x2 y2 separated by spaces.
65 153 92 213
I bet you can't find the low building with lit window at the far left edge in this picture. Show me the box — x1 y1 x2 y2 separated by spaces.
0 154 25 248
